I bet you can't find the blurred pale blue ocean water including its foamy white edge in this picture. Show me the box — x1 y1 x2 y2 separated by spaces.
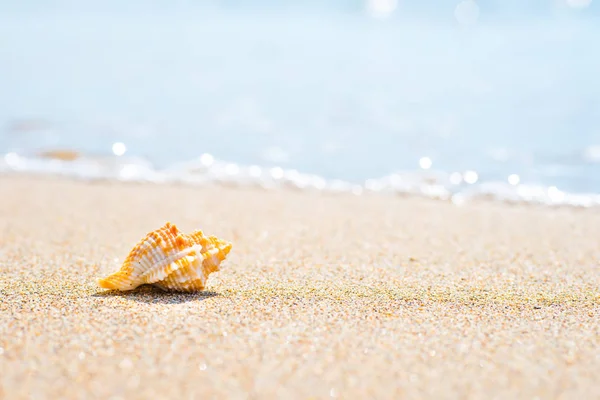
0 0 600 206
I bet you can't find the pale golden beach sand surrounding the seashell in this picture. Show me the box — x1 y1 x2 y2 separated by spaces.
0 176 600 400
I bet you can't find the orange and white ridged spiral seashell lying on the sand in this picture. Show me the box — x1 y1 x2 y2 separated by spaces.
98 222 231 292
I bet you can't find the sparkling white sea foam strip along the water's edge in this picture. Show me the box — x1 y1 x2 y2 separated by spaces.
0 153 600 208
